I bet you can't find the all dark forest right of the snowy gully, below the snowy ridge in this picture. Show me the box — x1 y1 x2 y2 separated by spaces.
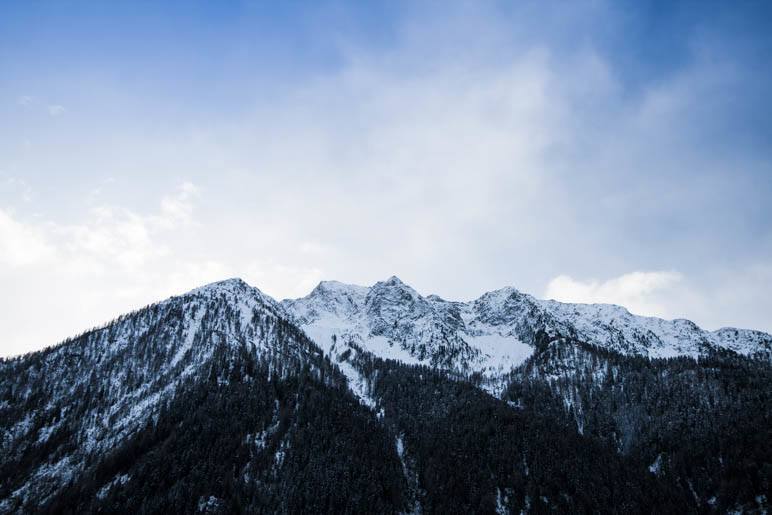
348 337 772 513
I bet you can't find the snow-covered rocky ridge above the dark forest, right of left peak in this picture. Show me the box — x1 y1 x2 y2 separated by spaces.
282 277 772 375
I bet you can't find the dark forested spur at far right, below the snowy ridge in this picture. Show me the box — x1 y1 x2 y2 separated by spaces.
504 339 772 512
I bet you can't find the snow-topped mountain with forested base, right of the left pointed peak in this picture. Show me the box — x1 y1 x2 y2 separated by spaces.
283 278 772 513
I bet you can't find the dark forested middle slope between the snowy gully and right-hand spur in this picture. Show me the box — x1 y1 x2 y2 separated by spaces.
344 354 691 513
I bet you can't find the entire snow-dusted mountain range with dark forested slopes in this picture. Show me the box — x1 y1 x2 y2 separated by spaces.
0 278 772 513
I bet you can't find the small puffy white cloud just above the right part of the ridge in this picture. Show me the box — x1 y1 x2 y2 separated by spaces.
544 271 683 317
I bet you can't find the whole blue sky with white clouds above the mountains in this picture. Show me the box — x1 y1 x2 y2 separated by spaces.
0 0 772 356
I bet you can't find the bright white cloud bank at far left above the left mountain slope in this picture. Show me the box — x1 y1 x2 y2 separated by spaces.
0 183 213 355
